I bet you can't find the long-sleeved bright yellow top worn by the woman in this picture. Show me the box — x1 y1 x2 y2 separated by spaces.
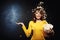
22 20 47 40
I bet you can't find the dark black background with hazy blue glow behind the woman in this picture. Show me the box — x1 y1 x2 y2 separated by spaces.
0 0 60 40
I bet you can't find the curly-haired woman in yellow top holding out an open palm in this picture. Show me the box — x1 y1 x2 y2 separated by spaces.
17 2 53 40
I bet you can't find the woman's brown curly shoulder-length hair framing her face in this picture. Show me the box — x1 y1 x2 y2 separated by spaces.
32 7 47 22
